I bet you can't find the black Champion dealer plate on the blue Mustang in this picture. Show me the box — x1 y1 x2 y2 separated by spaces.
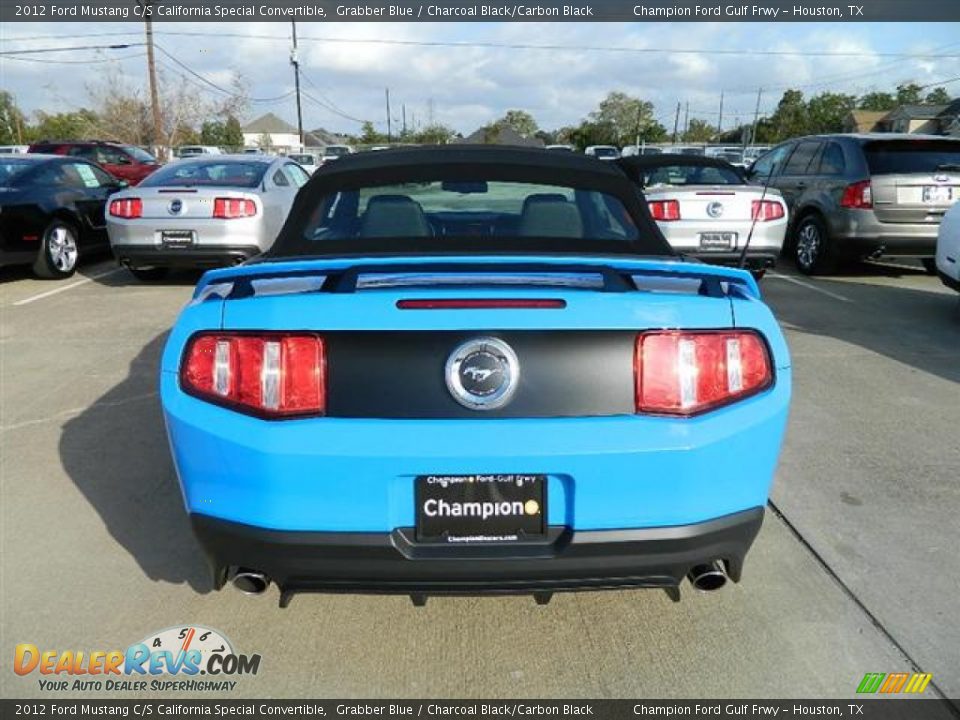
415 475 547 543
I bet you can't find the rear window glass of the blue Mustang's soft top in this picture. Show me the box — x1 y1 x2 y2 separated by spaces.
271 180 638 256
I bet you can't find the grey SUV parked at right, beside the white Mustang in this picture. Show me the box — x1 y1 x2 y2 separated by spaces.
747 133 960 274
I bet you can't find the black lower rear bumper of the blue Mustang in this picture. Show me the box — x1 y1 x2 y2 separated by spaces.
191 507 764 595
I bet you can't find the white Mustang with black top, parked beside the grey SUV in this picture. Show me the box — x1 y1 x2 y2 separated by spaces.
621 155 787 278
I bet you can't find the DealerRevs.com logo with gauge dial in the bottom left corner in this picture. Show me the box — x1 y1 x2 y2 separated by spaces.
13 625 260 692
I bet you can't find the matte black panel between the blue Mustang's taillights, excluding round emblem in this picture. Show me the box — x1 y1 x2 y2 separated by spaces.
324 331 637 419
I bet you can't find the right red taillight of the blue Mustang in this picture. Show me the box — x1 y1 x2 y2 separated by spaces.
634 330 773 415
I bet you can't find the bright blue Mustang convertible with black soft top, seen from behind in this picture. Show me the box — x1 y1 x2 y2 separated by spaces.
160 145 790 606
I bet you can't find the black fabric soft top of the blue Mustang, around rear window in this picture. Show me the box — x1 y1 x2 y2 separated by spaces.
264 145 675 258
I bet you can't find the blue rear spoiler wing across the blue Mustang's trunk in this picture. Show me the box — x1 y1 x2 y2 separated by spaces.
194 257 760 299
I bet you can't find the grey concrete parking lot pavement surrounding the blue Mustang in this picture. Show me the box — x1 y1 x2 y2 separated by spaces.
0 261 960 698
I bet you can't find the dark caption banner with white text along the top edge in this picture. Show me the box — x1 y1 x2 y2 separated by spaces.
0 0 960 23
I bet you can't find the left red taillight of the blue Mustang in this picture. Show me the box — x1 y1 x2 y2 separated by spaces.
180 333 326 418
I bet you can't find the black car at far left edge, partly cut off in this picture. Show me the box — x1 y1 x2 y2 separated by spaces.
0 155 127 278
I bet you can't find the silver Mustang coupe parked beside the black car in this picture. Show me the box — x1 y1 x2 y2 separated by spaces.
107 155 310 280
